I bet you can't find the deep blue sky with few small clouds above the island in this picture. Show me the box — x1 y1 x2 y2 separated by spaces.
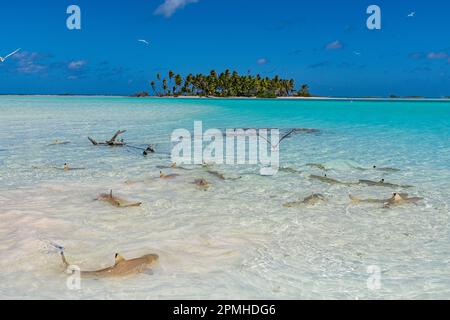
0 0 450 97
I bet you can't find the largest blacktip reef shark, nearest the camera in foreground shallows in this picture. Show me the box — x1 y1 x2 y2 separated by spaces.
60 250 159 278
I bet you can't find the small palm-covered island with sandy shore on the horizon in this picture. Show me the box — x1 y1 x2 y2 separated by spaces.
134 69 311 98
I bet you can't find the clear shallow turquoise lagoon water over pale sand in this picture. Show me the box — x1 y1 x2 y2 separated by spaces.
0 96 450 299
